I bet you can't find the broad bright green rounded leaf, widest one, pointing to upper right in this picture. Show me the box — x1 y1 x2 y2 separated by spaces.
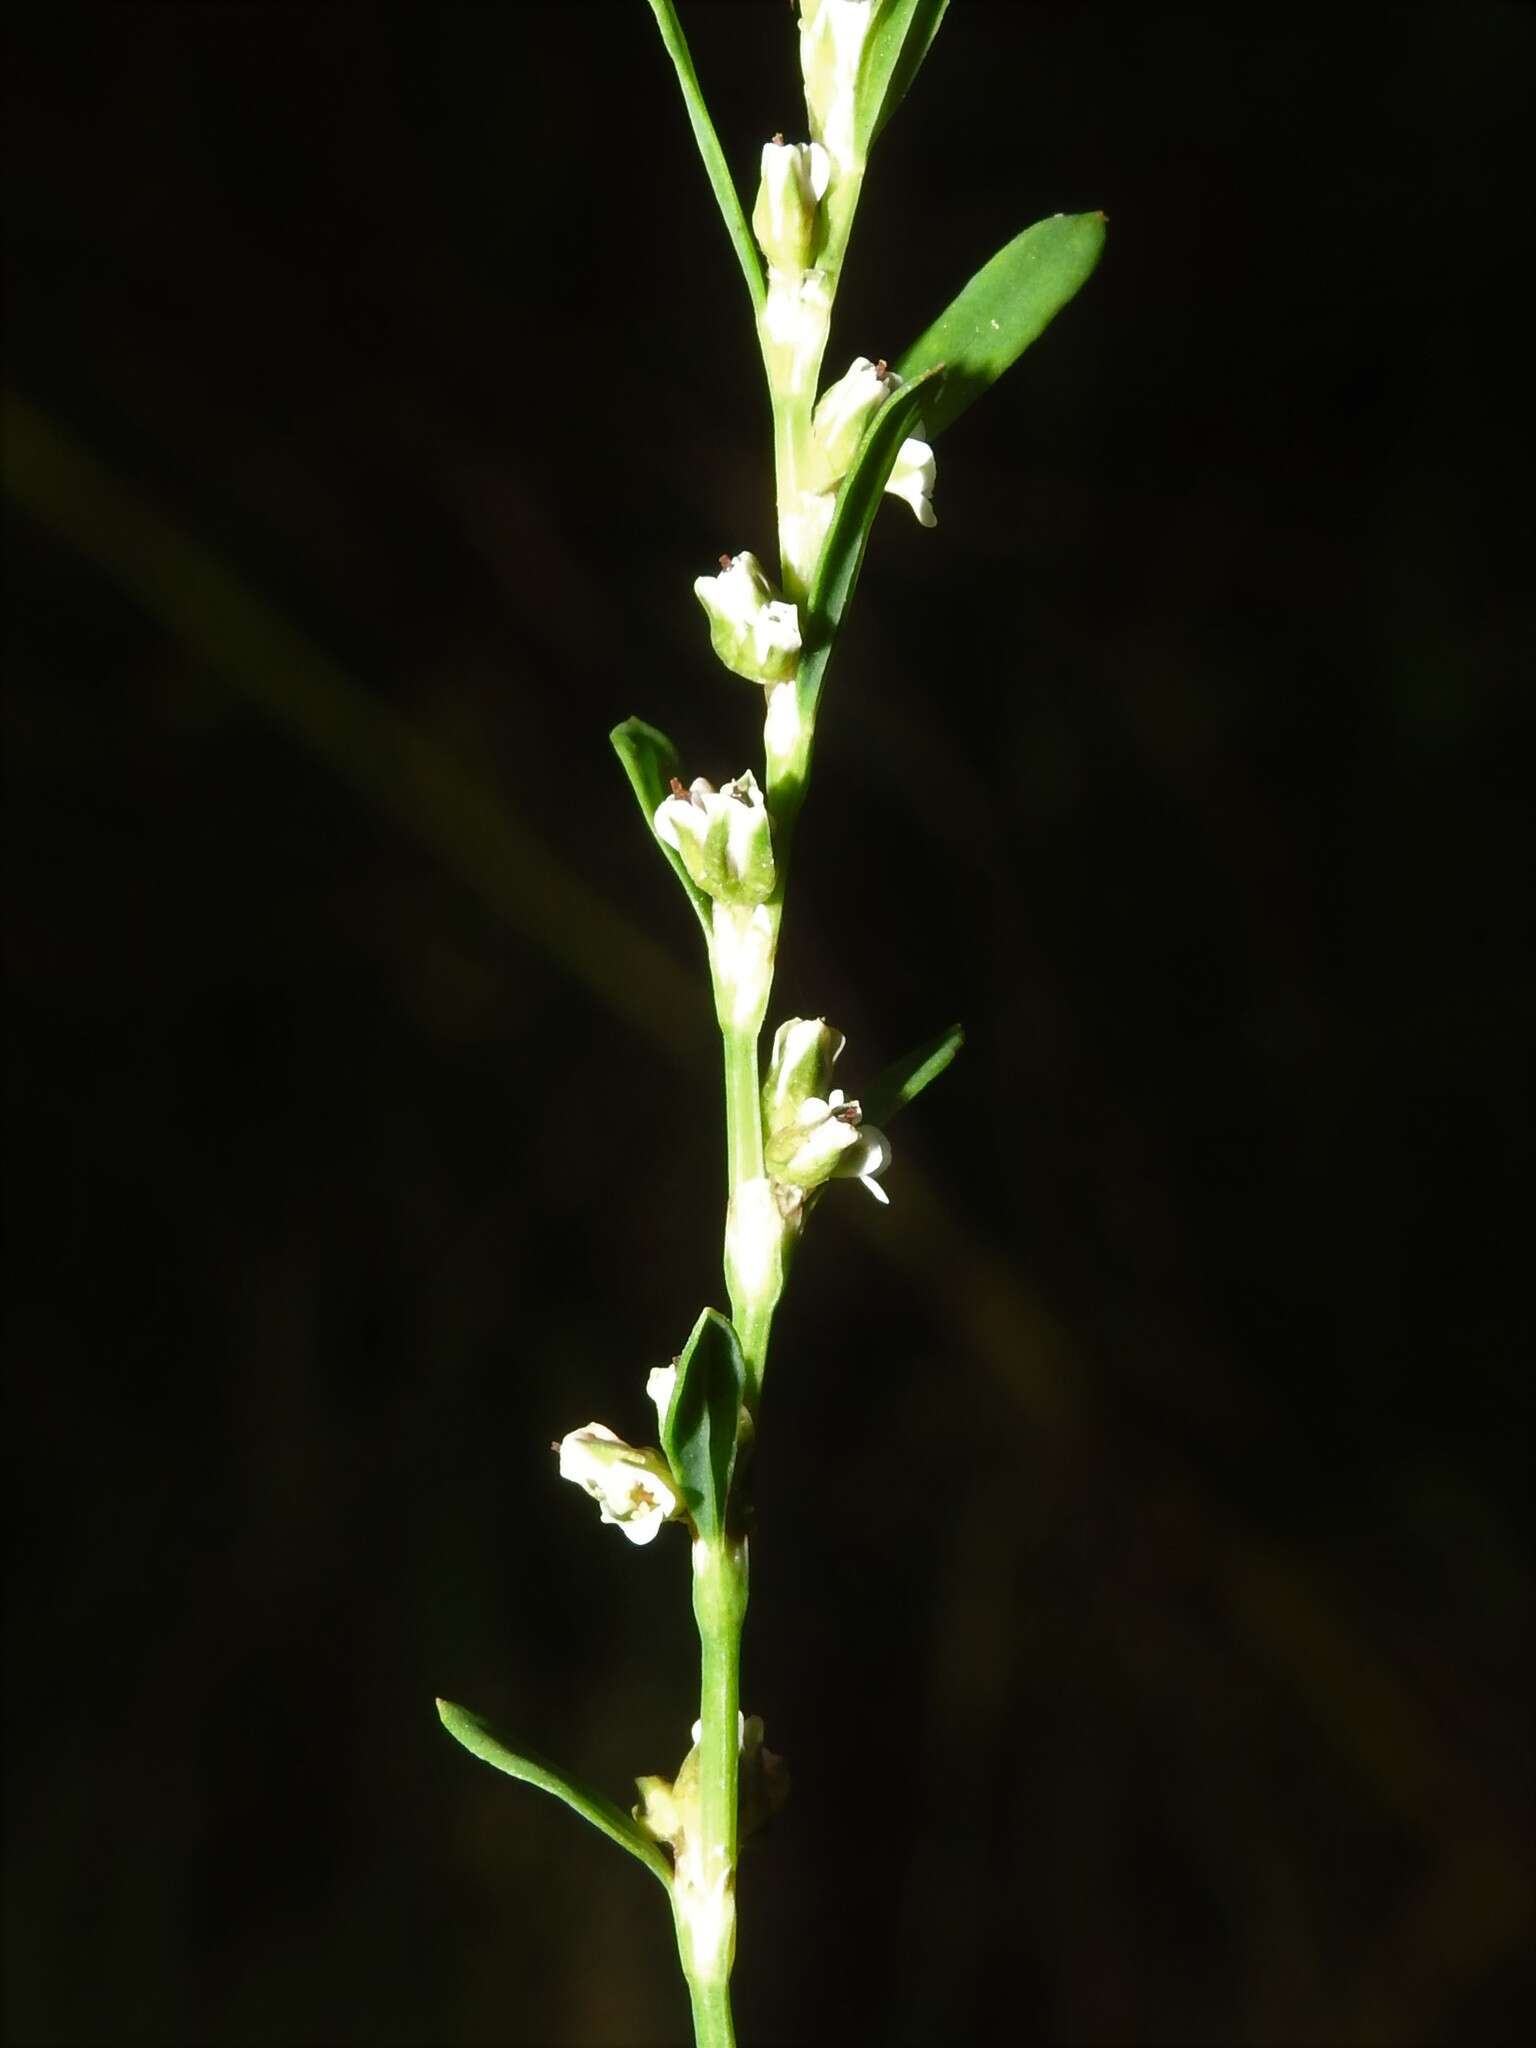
895 213 1104 440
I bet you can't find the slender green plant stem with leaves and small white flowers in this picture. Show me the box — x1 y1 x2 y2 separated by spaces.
438 0 1104 2048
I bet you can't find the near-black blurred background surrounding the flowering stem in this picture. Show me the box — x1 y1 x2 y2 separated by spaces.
6 0 1536 2048
